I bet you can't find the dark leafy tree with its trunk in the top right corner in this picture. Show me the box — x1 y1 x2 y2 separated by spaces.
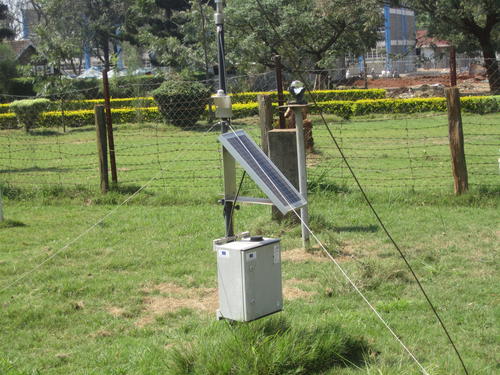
405 0 500 93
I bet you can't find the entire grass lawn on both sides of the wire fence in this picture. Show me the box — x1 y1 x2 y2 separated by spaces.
0 115 500 375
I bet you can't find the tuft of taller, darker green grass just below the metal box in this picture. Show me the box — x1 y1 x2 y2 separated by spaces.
170 317 368 375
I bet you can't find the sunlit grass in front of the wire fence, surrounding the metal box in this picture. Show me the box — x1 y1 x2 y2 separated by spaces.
0 187 499 375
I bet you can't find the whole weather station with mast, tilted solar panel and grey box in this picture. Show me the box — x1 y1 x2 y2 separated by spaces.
212 0 307 322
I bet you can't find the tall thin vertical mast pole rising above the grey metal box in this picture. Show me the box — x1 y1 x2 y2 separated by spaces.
214 0 236 237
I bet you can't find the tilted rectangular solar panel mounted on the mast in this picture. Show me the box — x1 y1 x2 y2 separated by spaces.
219 130 307 214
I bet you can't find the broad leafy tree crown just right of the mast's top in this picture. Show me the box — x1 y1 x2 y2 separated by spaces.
226 0 382 69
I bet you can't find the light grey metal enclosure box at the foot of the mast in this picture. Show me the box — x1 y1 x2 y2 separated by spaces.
214 237 283 322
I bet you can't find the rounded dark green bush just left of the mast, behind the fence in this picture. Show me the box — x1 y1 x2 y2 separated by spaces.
152 80 210 127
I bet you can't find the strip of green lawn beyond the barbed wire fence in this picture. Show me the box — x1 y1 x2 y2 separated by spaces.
0 114 500 197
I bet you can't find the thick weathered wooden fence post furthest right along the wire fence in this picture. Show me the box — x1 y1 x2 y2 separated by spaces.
445 87 469 195
